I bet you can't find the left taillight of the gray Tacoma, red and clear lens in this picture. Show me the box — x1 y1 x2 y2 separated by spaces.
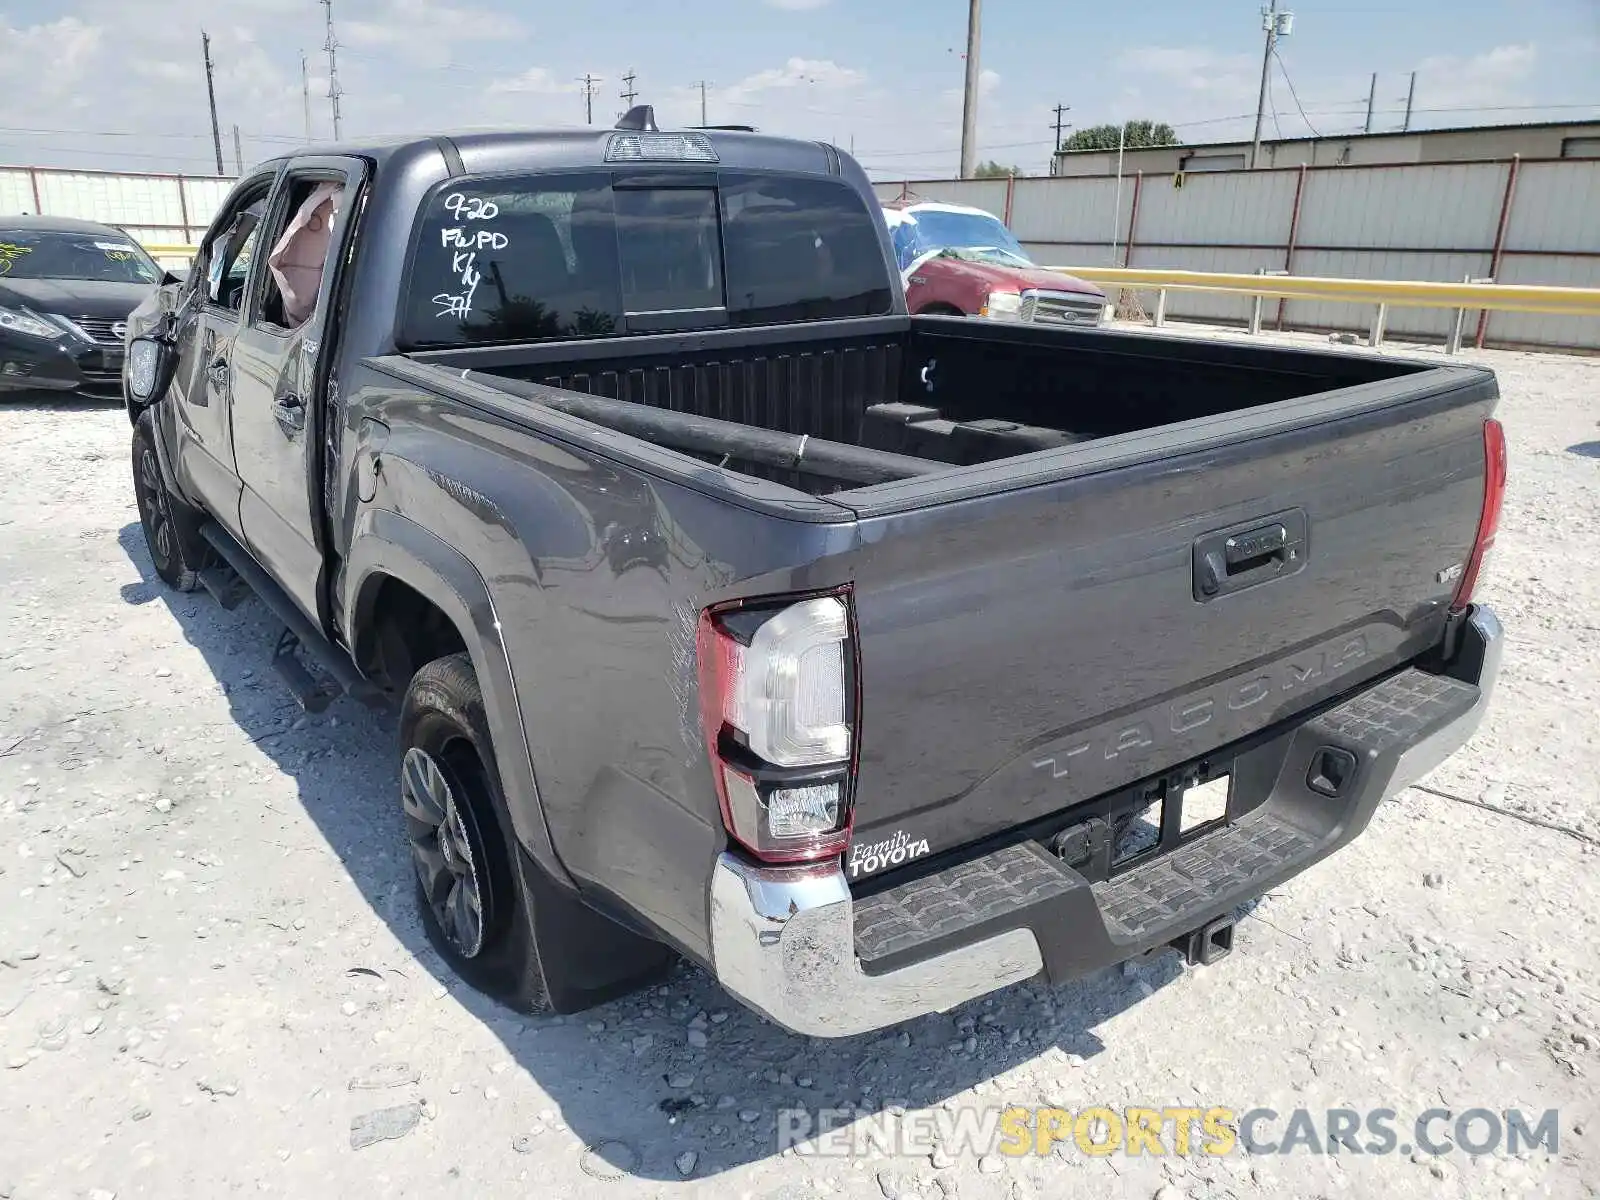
696 594 859 862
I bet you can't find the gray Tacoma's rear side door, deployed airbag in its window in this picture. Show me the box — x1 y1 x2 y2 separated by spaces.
230 158 362 624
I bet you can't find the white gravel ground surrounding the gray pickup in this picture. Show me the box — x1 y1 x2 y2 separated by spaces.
0 331 1600 1200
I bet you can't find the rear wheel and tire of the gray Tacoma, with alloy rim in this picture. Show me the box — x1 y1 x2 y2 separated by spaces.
400 654 550 1013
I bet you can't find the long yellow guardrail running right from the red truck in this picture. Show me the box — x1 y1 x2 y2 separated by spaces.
1046 267 1600 317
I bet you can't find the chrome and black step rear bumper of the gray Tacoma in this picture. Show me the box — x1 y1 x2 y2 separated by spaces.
710 606 1504 1037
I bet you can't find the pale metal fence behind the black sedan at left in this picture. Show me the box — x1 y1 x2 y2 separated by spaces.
0 166 234 245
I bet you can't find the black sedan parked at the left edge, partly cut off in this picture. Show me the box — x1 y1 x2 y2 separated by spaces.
0 216 162 397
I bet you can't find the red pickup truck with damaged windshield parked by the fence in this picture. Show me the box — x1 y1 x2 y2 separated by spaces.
883 202 1106 325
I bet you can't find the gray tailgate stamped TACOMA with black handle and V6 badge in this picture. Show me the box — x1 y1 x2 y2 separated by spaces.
834 368 1496 880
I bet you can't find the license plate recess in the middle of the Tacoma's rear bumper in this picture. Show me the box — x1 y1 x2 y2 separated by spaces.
1048 760 1235 883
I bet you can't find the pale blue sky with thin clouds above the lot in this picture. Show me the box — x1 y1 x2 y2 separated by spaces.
0 0 1600 178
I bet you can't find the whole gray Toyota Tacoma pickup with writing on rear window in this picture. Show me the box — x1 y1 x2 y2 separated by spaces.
125 110 1506 1035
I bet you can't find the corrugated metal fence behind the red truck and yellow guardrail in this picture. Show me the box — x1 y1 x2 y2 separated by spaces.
877 158 1600 349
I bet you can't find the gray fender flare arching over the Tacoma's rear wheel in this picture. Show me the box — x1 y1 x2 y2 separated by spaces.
341 509 576 890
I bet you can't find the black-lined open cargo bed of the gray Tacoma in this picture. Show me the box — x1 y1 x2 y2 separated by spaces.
403 317 1424 494
